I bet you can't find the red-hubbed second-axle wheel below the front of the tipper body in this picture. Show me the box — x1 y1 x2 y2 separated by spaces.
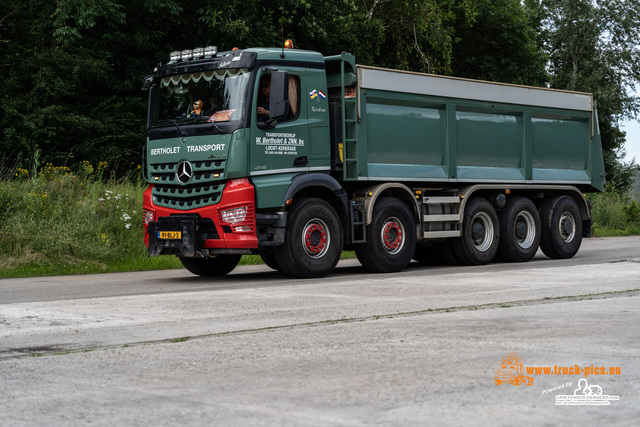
354 197 416 273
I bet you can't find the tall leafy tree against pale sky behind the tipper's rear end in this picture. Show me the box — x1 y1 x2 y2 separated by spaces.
540 0 640 191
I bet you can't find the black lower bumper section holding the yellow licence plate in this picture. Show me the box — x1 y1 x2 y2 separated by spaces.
148 215 202 257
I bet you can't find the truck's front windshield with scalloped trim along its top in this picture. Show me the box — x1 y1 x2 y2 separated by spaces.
151 68 250 128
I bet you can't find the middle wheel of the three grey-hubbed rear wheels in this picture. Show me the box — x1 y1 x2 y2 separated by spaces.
498 197 541 262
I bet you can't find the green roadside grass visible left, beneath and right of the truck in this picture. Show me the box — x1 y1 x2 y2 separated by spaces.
0 165 640 278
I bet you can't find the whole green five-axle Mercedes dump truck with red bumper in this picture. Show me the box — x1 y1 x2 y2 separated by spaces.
143 42 604 277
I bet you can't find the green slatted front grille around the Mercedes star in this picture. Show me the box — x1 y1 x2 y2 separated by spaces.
150 160 226 210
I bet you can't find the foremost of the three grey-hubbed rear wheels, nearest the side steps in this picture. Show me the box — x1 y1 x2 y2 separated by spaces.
451 197 500 265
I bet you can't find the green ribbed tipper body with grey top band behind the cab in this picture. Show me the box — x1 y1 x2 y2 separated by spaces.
327 54 604 192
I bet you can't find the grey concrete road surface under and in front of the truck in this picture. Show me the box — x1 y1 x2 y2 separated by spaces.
0 237 640 426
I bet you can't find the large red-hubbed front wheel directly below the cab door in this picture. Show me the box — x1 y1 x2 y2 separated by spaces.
273 198 343 278
